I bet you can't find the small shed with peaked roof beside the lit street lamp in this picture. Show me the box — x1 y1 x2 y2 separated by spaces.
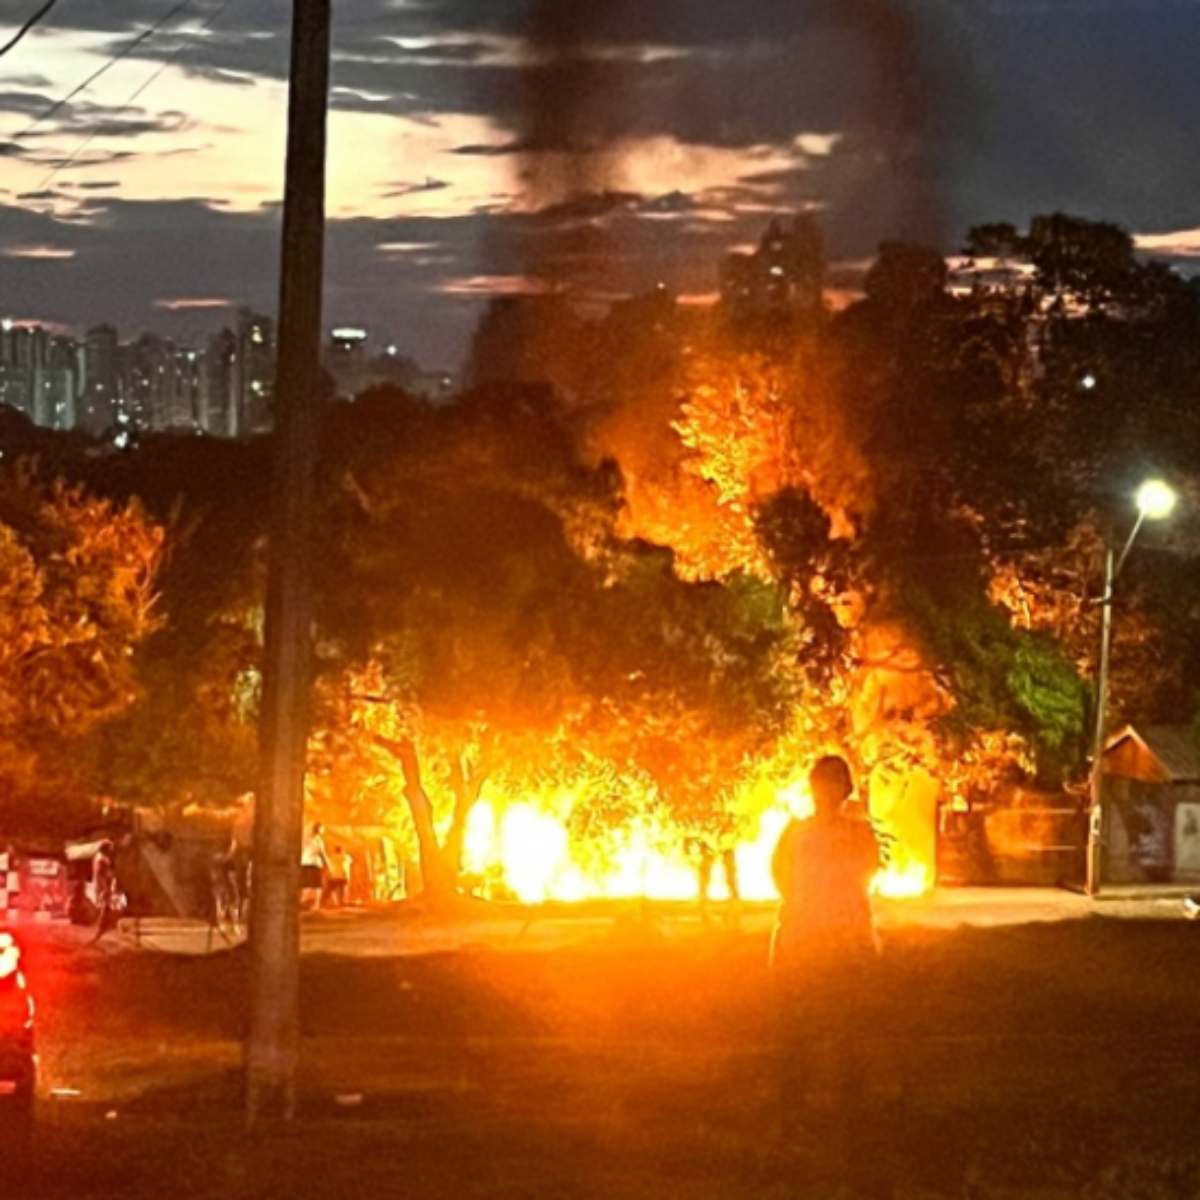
1103 725 1200 883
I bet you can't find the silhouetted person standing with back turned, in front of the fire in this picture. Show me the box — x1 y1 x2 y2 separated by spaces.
770 755 880 1172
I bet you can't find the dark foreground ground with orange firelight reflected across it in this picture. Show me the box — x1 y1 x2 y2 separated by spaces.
7 900 1200 1200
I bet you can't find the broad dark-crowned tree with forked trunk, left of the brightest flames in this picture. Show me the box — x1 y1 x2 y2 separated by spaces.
317 394 786 893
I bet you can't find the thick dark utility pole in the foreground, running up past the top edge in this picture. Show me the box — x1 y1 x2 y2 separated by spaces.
246 0 331 1123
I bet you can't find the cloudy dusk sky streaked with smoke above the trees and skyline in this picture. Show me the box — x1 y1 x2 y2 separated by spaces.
0 0 1200 366
